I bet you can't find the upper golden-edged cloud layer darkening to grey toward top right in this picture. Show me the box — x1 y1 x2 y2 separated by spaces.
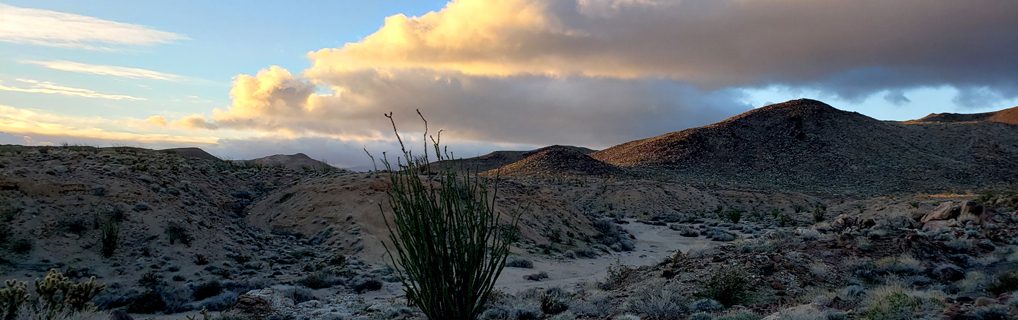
308 0 1018 98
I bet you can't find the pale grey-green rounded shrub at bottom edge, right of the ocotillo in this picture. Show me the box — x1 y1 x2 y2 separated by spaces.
626 283 688 320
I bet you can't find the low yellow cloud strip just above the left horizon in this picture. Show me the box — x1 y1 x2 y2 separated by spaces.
0 105 219 145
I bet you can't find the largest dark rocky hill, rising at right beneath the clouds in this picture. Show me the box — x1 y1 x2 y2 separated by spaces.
591 99 1018 192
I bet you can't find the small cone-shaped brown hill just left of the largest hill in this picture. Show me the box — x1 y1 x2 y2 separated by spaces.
488 146 618 176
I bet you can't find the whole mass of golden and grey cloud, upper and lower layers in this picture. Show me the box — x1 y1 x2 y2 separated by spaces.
188 0 1018 151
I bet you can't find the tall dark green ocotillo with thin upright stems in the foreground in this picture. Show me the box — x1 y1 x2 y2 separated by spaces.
380 110 517 320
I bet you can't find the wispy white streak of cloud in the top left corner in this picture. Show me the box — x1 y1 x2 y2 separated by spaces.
0 4 188 50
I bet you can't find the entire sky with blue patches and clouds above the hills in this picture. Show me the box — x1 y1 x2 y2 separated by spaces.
0 0 1018 168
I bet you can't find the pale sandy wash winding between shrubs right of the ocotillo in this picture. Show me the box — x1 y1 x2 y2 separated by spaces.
496 221 722 292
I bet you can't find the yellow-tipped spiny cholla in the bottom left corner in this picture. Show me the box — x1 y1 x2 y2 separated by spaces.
0 270 106 320
